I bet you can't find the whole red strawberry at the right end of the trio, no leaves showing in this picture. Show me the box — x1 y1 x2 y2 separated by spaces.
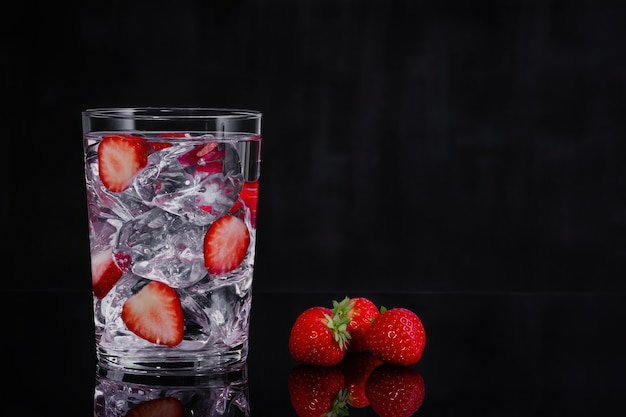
365 308 426 366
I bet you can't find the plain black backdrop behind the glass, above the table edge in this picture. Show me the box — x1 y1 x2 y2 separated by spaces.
0 0 626 293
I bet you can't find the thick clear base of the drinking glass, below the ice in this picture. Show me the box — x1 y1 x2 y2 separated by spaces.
97 344 248 384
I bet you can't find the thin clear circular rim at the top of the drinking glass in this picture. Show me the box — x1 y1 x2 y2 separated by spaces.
82 106 262 120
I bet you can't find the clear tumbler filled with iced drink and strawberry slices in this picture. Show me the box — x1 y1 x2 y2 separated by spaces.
83 108 261 375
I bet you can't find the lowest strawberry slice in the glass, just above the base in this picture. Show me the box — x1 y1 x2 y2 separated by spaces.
122 281 184 346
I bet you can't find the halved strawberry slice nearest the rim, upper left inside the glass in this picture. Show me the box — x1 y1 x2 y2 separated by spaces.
98 135 148 193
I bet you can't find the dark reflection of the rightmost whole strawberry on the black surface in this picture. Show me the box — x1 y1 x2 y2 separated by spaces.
365 364 425 417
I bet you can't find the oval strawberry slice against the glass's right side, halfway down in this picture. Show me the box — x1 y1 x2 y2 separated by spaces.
204 215 250 274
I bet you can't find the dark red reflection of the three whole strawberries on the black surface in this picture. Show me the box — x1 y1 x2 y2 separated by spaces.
287 352 425 417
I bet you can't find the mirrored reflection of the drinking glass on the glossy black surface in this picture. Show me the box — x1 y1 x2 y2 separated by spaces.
94 367 250 417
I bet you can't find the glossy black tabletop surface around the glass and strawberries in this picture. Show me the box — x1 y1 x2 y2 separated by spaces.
0 291 626 416
